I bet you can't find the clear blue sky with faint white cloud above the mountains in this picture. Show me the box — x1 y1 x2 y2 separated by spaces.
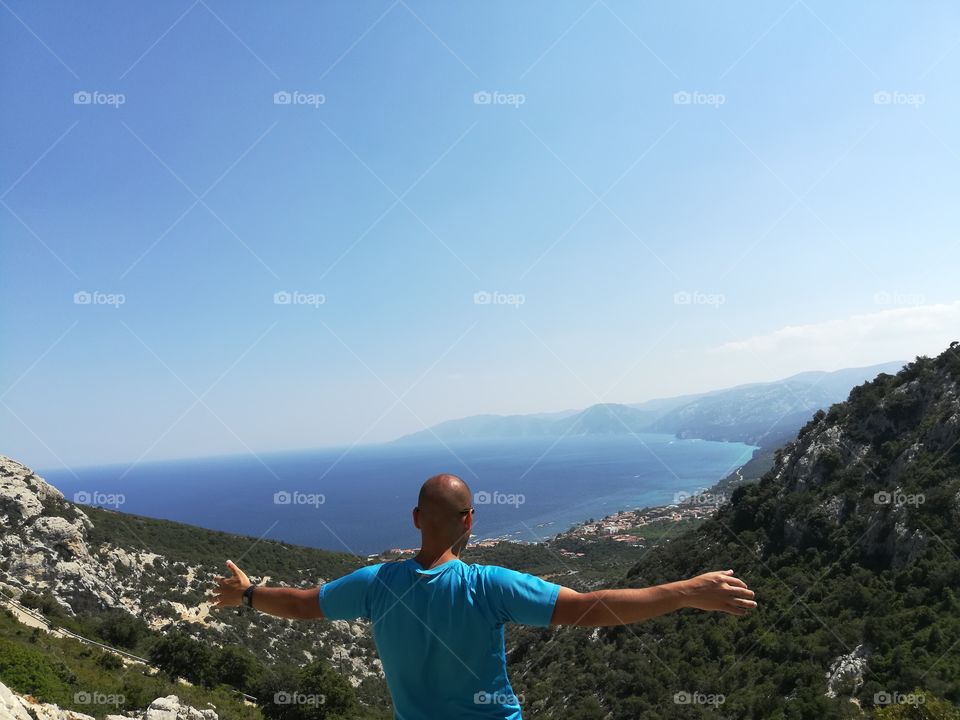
0 0 960 468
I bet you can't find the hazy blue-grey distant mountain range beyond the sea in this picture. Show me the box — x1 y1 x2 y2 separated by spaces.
395 360 905 448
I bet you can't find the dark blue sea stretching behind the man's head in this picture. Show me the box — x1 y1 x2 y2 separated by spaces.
41 434 754 555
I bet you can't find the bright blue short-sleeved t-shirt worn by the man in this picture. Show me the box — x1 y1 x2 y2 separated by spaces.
320 559 560 720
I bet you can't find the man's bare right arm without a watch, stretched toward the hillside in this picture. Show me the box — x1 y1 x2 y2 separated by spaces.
550 570 757 627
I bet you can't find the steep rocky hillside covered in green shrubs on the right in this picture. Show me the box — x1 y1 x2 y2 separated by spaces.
511 343 960 720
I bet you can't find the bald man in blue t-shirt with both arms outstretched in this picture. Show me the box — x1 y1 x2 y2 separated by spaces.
213 474 756 720
